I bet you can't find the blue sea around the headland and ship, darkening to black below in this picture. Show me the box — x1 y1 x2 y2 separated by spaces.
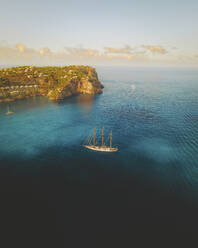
0 67 198 247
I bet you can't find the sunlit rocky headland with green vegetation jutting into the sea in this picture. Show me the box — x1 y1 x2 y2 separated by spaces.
0 66 103 102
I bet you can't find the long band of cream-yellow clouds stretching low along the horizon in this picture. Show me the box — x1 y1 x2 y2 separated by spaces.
0 41 198 65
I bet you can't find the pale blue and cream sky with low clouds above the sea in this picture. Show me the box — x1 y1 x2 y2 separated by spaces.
0 0 198 67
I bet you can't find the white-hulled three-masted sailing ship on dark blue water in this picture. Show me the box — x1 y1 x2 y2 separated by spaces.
83 127 118 152
